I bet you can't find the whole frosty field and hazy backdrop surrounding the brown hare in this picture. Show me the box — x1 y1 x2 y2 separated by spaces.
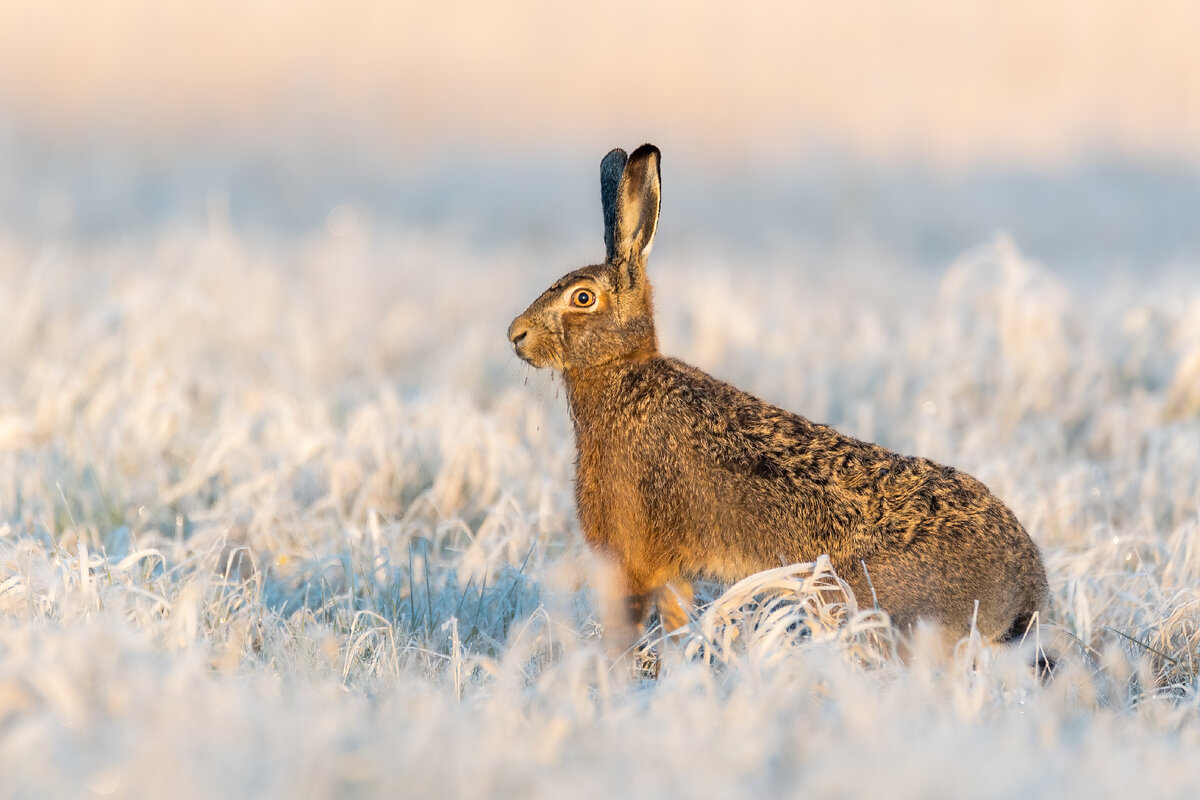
0 6 1200 800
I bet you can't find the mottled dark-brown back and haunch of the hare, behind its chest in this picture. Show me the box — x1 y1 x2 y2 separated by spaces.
656 360 1048 637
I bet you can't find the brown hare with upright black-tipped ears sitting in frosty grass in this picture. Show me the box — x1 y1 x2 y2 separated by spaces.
508 144 1048 645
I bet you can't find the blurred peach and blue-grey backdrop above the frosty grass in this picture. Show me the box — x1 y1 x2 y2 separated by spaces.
0 0 1200 277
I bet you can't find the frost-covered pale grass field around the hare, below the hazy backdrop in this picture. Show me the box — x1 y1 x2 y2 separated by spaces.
0 229 1200 798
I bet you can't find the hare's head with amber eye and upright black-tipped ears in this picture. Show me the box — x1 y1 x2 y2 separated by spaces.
509 144 660 369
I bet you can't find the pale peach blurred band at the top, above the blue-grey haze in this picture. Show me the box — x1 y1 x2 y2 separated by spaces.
0 0 1200 166
